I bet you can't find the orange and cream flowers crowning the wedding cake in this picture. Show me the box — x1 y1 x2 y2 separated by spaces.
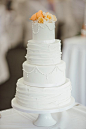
30 10 57 23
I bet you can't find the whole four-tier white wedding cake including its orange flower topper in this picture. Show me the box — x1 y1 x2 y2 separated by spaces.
15 10 71 110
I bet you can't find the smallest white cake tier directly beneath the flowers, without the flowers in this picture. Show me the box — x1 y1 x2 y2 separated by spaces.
32 22 55 42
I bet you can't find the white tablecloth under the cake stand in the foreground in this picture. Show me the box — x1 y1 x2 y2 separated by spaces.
0 104 86 129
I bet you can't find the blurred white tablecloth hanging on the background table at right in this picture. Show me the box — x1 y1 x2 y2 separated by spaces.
62 36 86 105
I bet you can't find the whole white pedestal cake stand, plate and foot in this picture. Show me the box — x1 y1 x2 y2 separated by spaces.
12 97 75 127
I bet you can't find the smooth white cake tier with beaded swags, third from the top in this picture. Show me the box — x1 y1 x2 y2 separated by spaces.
23 61 66 87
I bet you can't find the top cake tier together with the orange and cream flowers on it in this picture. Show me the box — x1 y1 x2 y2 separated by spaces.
30 10 57 43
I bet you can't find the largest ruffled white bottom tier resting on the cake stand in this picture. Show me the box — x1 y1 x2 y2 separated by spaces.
15 78 71 109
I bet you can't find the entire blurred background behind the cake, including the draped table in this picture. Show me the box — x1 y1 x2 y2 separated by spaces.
0 0 86 110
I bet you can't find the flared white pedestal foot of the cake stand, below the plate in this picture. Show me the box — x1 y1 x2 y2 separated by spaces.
34 113 57 127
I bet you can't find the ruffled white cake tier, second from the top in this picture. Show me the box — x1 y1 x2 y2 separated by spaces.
26 40 61 65
